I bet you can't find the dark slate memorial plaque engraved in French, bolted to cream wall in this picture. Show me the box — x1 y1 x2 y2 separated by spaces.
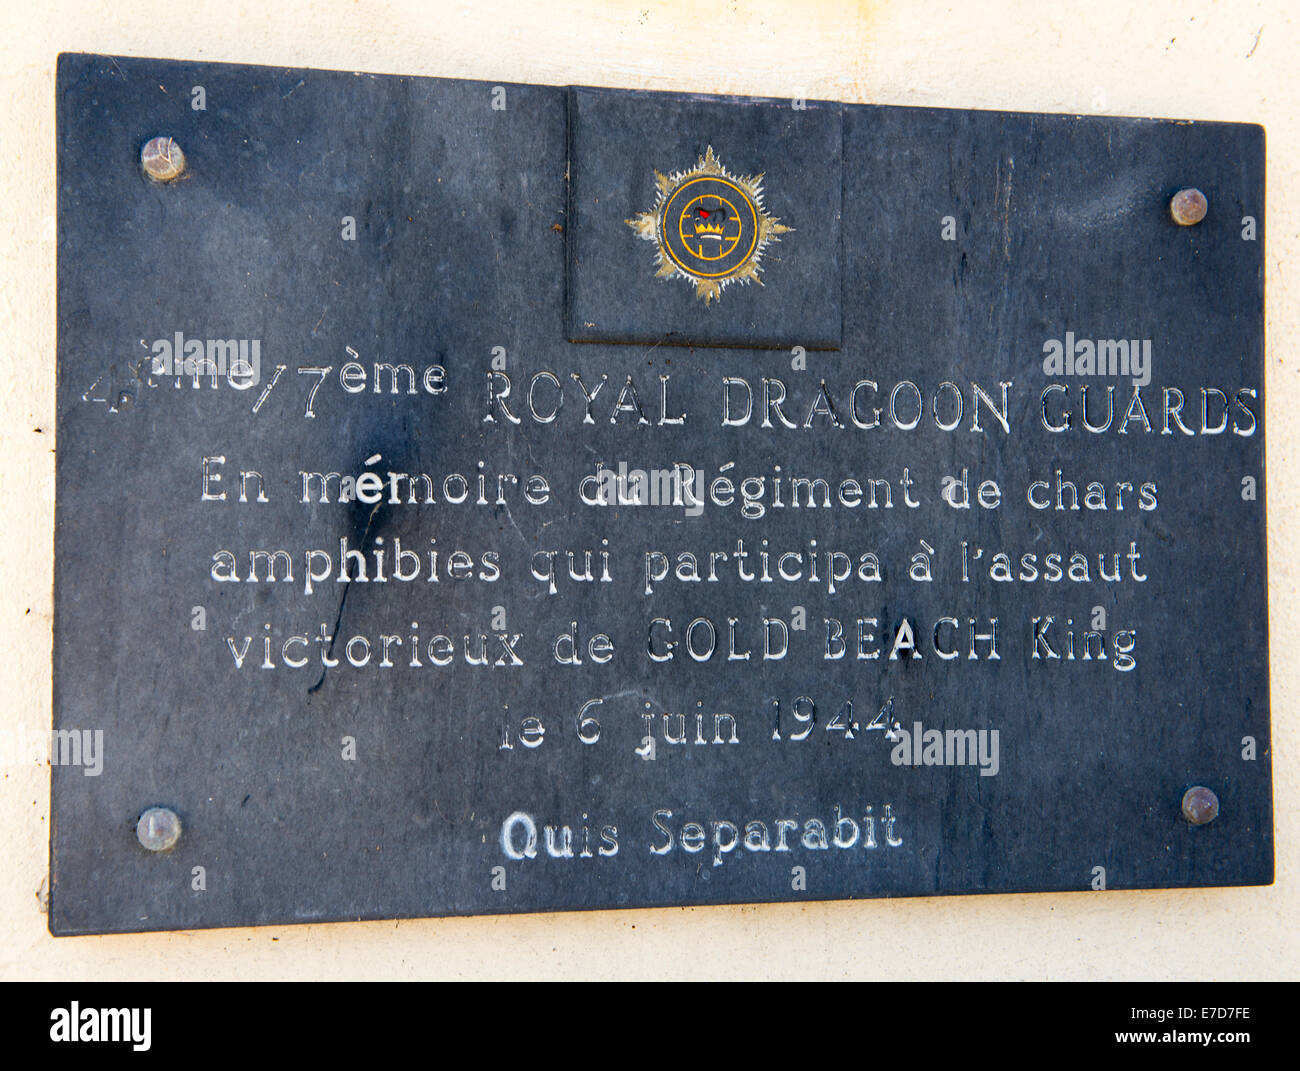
49 56 1273 935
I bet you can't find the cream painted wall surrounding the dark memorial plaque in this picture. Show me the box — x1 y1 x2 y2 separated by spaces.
0 0 1300 979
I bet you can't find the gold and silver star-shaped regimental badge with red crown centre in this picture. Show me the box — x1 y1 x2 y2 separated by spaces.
627 146 793 305
